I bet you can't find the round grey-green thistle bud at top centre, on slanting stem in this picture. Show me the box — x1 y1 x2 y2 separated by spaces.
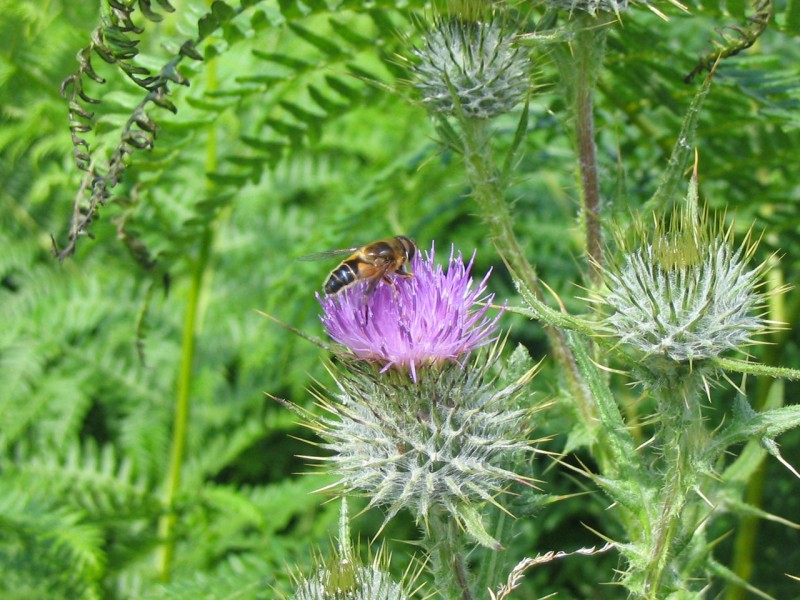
412 16 531 119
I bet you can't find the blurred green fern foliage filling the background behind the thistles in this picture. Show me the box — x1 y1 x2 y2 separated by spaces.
0 0 800 598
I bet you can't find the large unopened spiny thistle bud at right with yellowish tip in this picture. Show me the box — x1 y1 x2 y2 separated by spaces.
602 181 768 367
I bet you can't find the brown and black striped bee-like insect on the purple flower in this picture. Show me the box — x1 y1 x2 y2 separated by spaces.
301 235 417 296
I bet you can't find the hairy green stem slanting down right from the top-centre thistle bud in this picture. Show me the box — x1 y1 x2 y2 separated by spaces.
461 118 598 462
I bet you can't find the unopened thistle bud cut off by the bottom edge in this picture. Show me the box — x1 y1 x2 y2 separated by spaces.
294 499 413 600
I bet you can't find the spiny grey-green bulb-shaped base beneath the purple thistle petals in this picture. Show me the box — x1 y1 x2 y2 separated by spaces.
312 347 532 547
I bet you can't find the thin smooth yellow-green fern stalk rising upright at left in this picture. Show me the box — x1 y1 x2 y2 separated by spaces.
157 60 217 581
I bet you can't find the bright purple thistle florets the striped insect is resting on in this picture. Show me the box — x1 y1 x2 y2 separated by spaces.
317 245 501 381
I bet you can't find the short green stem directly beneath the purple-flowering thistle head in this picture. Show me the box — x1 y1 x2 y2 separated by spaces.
428 513 475 600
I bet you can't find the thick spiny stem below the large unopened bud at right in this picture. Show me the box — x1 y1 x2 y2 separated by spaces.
642 374 708 600
